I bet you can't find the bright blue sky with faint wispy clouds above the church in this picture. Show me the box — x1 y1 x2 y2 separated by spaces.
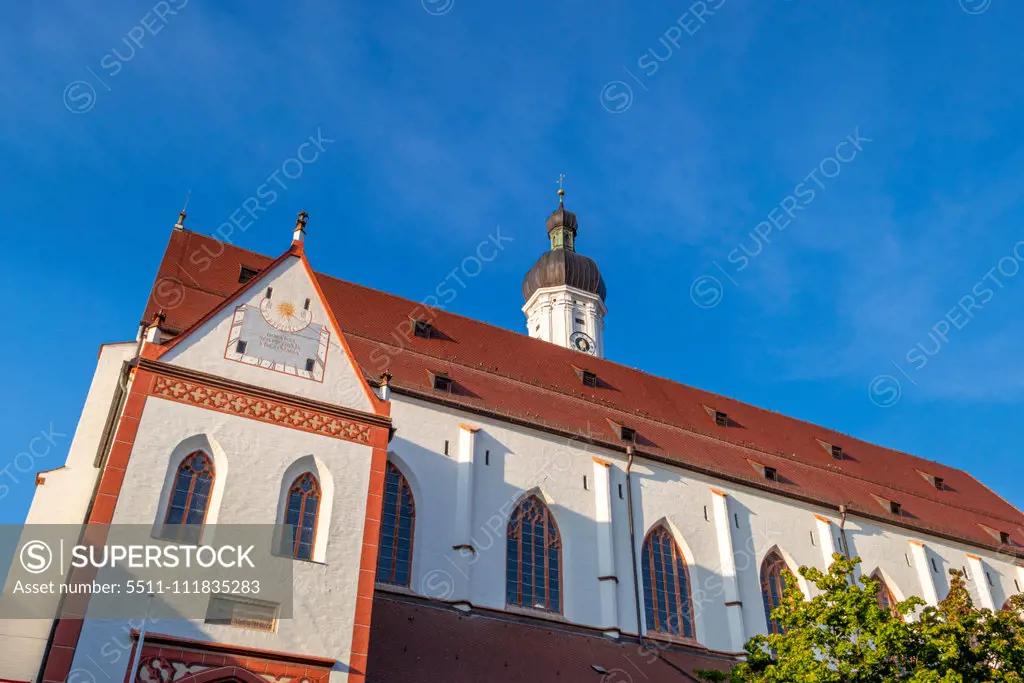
0 0 1024 522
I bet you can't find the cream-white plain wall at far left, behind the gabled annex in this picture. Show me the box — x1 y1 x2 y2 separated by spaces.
0 342 136 681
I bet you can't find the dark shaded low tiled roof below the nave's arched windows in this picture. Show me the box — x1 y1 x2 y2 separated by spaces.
367 592 735 683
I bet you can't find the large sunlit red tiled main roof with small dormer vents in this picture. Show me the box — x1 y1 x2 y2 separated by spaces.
143 230 1024 556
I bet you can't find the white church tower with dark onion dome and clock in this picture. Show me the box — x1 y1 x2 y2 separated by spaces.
522 184 607 357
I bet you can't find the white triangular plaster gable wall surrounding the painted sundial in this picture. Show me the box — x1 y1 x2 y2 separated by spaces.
161 256 372 412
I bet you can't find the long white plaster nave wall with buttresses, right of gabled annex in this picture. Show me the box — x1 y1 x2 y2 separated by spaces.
389 395 1017 651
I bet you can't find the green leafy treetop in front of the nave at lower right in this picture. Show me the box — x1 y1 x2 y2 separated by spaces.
700 554 1024 683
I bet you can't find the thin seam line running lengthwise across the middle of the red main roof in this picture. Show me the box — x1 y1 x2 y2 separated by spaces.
342 327 1021 524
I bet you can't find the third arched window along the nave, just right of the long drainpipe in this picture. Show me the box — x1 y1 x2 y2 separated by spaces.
642 525 694 638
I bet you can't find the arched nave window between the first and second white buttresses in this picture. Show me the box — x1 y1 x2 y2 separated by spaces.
505 496 562 612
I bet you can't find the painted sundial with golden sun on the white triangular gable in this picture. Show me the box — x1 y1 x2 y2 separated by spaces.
224 288 331 382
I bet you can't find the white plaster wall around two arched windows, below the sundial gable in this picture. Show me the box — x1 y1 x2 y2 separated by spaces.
74 397 372 681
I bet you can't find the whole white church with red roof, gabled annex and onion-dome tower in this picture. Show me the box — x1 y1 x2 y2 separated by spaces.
0 203 1024 683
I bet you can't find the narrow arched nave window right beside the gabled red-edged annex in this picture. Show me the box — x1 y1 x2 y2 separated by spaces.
377 462 416 586
